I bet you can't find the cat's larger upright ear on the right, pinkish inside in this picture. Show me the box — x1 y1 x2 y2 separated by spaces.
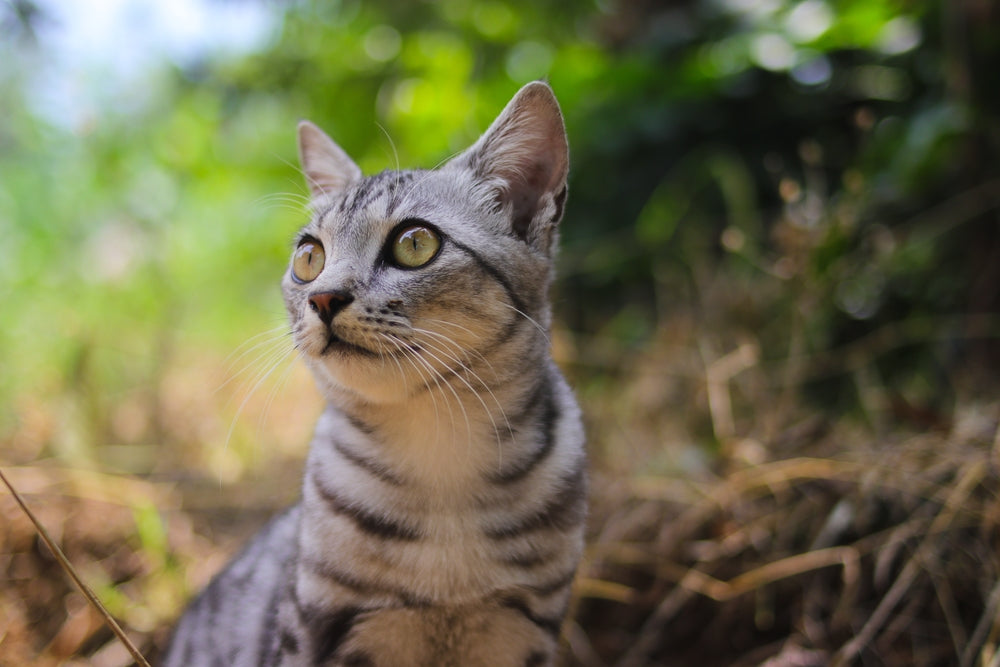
454 81 569 253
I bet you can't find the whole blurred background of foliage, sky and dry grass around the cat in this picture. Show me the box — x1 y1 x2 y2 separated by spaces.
0 0 1000 665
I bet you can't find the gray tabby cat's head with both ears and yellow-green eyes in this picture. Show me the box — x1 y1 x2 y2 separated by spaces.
282 82 568 402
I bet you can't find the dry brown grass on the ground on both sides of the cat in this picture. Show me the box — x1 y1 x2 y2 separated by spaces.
0 322 1000 667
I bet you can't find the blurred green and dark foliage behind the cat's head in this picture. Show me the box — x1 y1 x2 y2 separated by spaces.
0 0 1000 458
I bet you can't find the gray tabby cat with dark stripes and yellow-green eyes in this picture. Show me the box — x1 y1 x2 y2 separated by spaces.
165 82 586 667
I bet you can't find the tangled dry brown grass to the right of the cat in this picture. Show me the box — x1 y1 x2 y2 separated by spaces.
567 310 1000 667
